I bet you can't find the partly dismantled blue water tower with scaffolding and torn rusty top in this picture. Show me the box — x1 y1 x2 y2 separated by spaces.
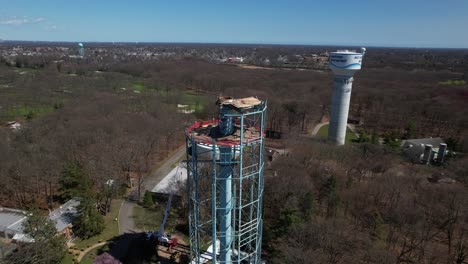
186 97 267 264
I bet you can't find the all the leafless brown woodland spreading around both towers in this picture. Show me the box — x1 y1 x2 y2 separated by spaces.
0 44 468 264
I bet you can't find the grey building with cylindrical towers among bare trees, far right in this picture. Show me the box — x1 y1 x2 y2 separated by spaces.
401 137 447 164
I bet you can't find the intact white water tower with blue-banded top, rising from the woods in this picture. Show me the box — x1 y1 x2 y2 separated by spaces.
328 48 366 145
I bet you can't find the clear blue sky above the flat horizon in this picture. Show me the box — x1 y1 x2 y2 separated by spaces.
0 0 468 48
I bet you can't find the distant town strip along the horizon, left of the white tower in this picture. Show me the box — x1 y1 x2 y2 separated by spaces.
0 42 328 69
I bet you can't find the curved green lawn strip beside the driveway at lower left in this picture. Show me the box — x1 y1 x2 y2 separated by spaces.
74 199 122 249
